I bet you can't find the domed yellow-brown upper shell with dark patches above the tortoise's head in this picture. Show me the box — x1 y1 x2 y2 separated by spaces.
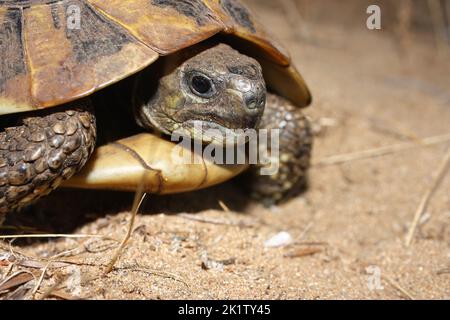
0 0 310 115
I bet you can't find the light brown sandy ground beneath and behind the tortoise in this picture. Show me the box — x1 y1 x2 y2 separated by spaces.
0 1 450 299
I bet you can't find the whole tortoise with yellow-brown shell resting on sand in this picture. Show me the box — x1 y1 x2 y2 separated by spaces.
0 0 312 222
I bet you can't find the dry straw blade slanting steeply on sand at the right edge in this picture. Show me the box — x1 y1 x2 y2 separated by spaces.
405 148 450 247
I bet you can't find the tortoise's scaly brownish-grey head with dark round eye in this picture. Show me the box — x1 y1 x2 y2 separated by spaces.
135 44 266 142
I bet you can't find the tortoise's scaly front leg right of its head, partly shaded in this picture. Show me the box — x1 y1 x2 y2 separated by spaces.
250 93 313 206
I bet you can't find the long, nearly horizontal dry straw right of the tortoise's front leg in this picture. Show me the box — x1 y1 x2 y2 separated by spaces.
313 134 450 167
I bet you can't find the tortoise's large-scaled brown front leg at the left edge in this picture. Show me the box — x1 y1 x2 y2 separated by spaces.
0 99 96 222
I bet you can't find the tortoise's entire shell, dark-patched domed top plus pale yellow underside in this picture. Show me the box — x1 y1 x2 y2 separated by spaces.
0 0 311 193
